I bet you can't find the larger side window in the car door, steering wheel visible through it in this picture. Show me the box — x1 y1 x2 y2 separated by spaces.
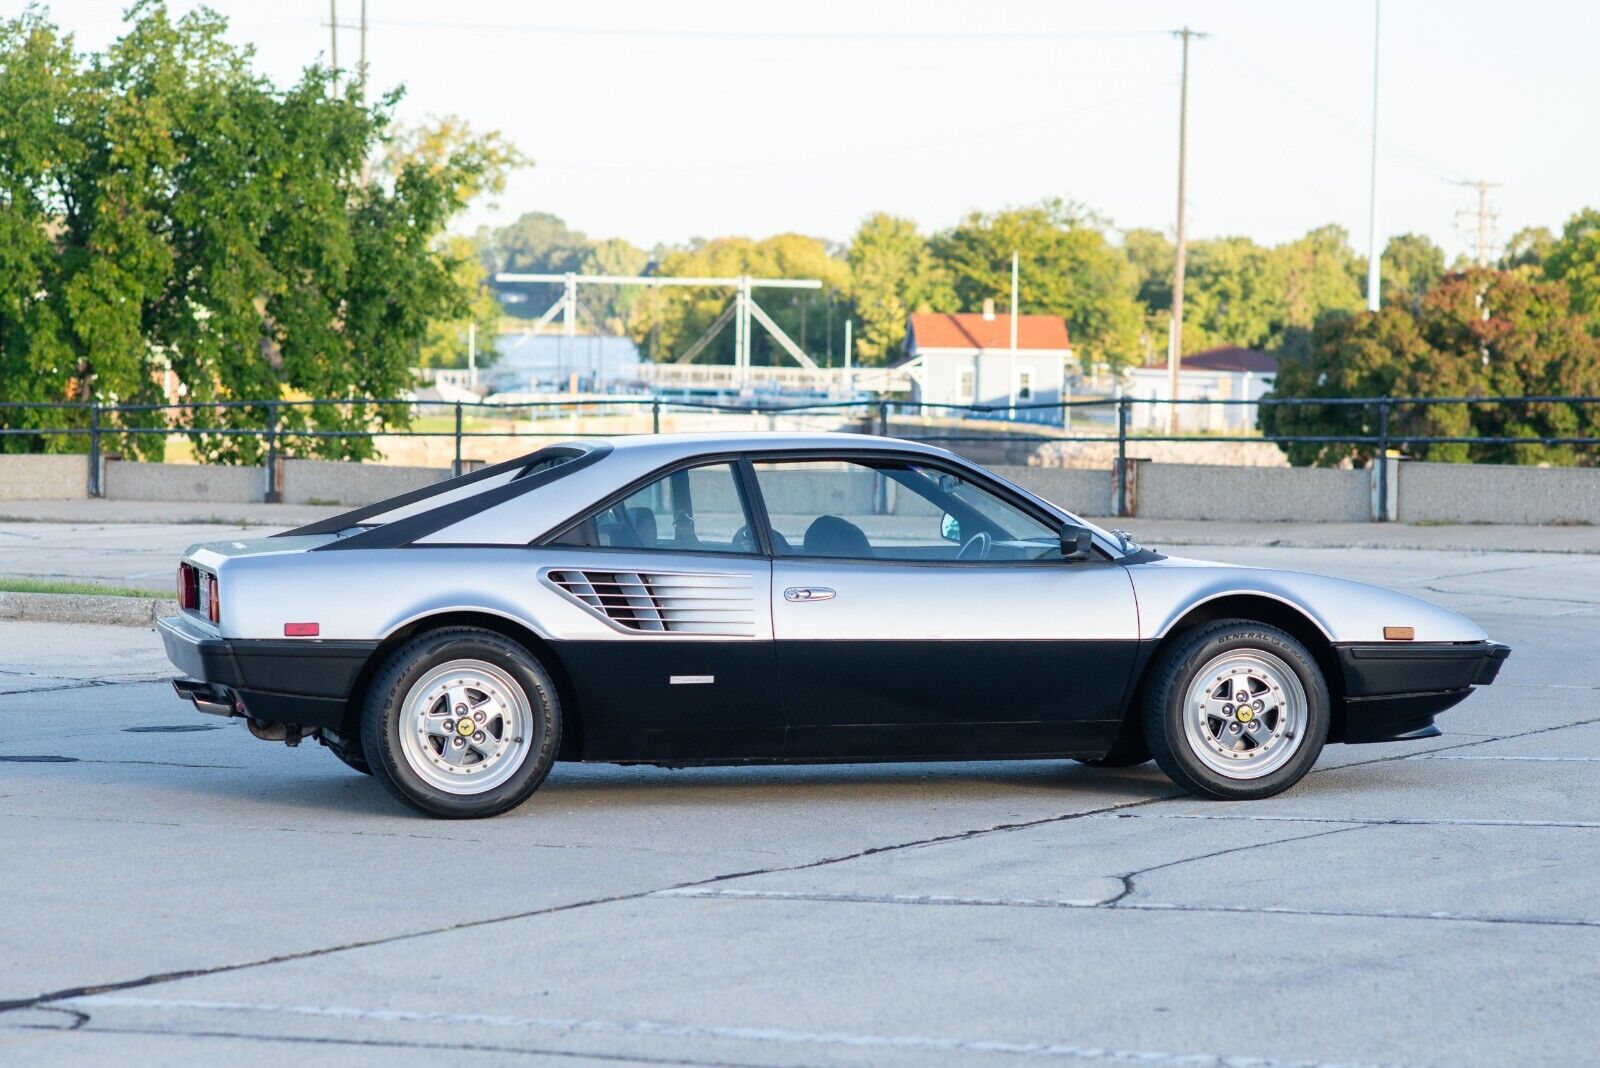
755 460 1061 563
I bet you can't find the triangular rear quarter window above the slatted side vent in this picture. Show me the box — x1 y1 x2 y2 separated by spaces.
549 464 758 553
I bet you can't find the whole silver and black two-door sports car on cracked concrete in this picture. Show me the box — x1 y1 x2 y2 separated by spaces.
160 433 1510 817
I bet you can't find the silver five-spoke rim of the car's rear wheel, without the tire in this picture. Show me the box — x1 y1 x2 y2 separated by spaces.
400 660 533 795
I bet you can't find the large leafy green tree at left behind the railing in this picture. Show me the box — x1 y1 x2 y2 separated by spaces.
0 2 517 460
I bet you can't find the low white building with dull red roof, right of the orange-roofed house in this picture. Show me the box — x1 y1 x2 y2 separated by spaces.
1123 349 1278 433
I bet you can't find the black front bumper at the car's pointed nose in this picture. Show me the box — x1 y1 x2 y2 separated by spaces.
1334 641 1510 742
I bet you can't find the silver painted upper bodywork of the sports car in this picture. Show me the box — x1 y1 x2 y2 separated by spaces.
186 433 1486 643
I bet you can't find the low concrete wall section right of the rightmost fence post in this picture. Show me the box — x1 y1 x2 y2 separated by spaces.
1397 464 1600 524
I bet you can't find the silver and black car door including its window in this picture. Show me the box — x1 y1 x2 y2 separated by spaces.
752 452 1138 759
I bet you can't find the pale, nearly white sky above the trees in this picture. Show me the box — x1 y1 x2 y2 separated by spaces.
37 0 1600 254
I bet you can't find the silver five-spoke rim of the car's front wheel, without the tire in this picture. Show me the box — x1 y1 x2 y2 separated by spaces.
1184 649 1307 779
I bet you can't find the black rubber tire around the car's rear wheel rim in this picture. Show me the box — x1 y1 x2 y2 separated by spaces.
362 627 562 819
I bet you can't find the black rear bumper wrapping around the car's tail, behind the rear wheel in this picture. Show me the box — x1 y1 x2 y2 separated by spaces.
155 616 378 729
